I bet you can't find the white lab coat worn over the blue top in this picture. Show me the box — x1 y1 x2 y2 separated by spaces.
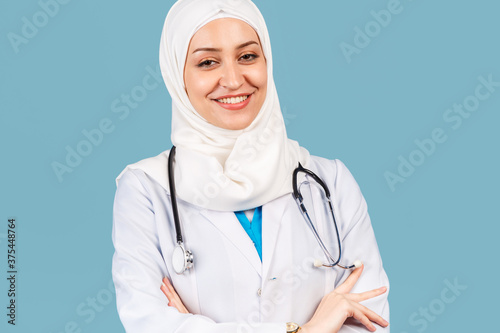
112 155 389 333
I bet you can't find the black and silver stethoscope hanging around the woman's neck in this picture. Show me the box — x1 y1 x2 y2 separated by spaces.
168 146 361 274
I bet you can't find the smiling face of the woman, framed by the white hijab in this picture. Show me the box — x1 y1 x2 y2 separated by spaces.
184 18 267 130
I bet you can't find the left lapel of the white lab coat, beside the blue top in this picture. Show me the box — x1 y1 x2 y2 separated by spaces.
201 210 264 276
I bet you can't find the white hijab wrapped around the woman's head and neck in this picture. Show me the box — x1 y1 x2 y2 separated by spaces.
119 0 309 211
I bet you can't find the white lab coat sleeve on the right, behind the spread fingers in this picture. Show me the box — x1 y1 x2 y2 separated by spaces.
334 160 390 333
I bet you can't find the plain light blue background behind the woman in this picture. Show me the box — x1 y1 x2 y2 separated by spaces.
0 0 500 333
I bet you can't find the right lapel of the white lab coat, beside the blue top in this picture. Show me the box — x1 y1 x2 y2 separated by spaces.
262 194 292 278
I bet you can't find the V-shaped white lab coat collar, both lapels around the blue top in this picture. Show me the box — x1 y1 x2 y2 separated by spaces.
201 194 292 277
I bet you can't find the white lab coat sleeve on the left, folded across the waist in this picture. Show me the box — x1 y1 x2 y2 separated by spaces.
112 170 286 333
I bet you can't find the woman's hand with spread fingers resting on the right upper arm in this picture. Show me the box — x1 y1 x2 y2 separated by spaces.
301 266 389 333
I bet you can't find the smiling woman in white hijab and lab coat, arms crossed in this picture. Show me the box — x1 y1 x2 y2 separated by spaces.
113 0 389 333
